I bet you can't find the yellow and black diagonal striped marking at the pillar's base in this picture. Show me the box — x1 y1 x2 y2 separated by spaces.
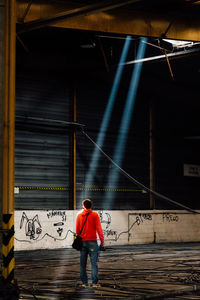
2 214 15 283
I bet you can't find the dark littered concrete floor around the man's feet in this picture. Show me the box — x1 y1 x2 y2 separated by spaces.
15 243 200 300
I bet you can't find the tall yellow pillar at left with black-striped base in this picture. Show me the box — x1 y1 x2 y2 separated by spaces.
2 0 16 282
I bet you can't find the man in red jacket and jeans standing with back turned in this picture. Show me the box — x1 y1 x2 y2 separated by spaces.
76 199 104 287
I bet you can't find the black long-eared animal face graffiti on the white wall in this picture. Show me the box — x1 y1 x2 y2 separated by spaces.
20 212 42 240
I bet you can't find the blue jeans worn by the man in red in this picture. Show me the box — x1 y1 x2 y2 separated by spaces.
80 241 99 284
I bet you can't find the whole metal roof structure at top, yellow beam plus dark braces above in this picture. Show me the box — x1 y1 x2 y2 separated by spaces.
17 0 200 41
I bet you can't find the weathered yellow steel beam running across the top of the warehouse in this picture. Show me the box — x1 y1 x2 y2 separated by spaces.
17 0 200 41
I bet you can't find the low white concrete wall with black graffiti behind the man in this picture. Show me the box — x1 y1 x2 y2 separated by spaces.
15 210 200 251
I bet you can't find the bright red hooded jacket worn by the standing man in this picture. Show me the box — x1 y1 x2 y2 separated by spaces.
76 208 104 244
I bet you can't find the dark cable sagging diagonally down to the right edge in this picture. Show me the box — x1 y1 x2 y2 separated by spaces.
81 127 200 214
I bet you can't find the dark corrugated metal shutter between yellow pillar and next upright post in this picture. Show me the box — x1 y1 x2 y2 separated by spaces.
15 73 69 209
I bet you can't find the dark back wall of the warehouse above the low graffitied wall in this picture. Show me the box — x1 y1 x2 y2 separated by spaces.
15 28 200 211
